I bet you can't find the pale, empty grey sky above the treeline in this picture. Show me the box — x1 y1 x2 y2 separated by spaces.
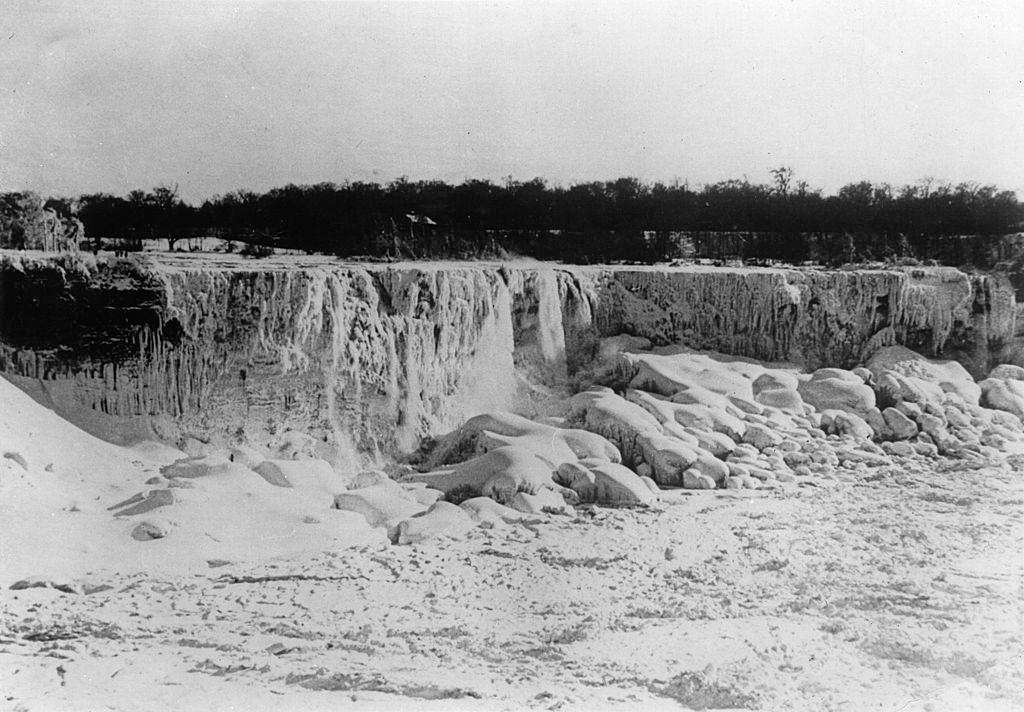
0 0 1024 202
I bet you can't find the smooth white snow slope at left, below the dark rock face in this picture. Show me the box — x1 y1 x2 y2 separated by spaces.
0 378 384 591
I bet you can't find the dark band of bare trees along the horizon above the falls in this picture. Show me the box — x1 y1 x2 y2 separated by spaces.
69 167 1024 263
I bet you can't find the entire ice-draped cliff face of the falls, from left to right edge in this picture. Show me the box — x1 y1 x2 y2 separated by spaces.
0 254 1016 457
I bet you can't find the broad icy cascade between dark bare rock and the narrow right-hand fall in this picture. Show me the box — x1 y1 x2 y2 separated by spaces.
134 265 528 461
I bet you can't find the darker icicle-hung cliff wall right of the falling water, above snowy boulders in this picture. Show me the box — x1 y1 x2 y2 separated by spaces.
586 266 1016 373
